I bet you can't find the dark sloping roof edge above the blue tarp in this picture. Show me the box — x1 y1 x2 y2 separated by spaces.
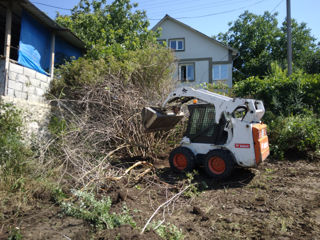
11 0 85 49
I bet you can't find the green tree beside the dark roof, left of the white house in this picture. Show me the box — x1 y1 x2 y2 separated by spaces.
56 0 156 58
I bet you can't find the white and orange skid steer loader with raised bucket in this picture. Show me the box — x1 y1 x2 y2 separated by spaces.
142 87 269 179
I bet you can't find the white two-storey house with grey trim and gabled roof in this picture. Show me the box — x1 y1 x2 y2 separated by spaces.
152 15 238 87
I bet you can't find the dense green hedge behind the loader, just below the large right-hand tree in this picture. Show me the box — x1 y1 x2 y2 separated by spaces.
233 64 320 116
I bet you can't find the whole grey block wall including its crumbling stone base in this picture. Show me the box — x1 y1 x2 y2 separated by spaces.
0 59 51 143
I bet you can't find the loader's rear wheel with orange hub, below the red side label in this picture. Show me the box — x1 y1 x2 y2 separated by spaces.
204 150 235 180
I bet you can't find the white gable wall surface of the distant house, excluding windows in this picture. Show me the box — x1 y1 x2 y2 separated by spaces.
159 20 232 87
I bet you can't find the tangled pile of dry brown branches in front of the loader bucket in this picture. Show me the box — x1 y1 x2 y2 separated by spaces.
45 69 179 186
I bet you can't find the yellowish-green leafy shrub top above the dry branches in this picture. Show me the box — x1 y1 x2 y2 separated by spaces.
51 44 174 95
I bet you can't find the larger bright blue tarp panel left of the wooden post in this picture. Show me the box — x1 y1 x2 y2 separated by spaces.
18 12 51 74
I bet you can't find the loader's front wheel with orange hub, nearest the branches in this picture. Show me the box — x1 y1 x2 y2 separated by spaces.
169 147 195 173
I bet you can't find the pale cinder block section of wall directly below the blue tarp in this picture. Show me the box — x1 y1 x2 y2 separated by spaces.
5 62 51 103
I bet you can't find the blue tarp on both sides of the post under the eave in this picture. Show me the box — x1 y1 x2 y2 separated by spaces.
18 12 82 74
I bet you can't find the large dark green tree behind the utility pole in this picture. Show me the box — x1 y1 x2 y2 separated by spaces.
216 11 315 80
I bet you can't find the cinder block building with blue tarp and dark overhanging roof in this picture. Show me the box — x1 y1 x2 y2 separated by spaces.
0 0 84 103
